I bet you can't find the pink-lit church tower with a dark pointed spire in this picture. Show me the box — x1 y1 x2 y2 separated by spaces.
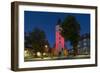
55 19 68 55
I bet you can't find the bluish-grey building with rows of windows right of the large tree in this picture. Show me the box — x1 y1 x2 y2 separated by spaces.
77 33 90 55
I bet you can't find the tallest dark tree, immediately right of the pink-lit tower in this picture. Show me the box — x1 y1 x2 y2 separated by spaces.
61 15 80 56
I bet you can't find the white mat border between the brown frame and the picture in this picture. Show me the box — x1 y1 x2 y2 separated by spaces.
18 5 95 68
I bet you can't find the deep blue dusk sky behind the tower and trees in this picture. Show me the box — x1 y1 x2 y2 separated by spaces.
24 11 90 47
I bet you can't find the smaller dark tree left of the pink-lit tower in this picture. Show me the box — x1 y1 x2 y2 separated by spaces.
30 28 46 53
